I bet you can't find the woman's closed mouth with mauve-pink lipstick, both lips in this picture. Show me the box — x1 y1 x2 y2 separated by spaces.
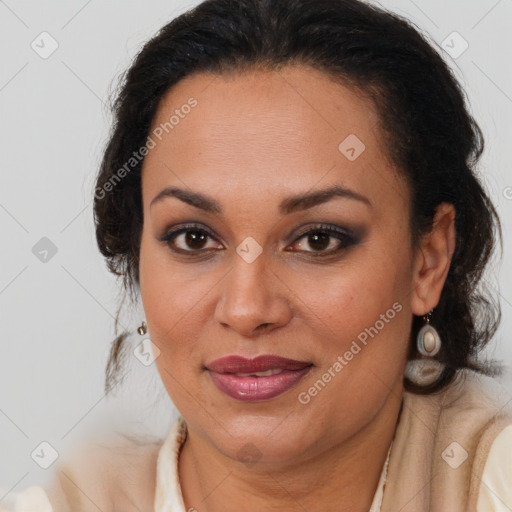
205 355 313 402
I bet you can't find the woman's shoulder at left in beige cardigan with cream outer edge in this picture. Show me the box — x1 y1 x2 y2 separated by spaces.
0 433 162 512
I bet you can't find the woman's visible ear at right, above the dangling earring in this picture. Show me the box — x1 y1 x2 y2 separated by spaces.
411 203 456 316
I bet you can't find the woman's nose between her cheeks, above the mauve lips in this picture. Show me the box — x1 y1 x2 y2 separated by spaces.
214 251 292 337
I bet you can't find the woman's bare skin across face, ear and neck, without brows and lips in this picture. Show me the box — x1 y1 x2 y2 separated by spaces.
140 66 455 512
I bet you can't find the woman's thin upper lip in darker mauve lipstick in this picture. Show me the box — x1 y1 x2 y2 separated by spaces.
206 355 312 373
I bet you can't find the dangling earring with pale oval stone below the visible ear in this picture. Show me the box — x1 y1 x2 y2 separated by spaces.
405 310 444 386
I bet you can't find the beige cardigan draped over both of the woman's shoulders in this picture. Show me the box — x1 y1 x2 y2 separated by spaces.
5 371 512 512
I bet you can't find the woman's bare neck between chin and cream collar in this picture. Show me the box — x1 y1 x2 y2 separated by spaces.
178 382 402 512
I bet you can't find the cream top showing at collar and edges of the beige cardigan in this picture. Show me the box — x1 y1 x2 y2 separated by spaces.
0 418 512 512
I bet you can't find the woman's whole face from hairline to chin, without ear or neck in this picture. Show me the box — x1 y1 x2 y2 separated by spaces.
140 67 418 462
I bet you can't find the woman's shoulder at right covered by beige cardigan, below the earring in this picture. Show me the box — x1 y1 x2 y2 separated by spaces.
383 371 512 512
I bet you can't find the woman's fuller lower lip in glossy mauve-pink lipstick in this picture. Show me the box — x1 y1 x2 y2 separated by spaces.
209 366 311 402
